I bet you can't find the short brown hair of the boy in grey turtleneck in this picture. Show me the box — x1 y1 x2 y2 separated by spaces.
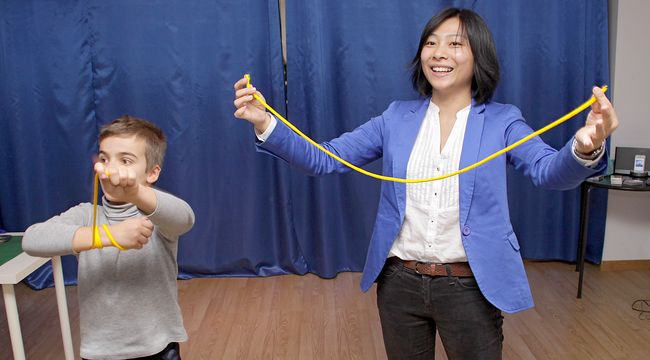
99 115 167 172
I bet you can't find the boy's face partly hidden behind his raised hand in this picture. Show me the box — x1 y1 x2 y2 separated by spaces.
98 135 160 191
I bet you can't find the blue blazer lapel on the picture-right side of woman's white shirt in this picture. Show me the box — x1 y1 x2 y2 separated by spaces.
459 99 485 227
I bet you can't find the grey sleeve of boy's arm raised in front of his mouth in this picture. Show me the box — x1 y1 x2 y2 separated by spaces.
148 189 194 239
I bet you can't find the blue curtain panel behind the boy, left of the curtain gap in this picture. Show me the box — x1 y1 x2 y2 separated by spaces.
0 0 294 287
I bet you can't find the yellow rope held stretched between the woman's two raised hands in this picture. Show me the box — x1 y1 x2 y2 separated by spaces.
244 74 607 183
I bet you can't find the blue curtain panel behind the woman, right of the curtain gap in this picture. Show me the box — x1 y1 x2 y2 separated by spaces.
286 0 609 270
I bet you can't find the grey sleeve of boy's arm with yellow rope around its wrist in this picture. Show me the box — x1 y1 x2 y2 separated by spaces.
22 203 92 257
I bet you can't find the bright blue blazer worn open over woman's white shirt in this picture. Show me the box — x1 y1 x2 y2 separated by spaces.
257 98 607 313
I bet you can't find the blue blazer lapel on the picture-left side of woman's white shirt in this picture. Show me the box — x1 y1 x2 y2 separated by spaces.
391 98 431 220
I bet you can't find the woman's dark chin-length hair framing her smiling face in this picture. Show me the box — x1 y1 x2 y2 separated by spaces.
411 8 499 104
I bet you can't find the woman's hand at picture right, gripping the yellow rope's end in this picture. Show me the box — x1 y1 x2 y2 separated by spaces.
576 87 618 154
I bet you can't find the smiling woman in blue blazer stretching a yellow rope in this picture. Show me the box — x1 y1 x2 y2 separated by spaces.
234 8 618 359
